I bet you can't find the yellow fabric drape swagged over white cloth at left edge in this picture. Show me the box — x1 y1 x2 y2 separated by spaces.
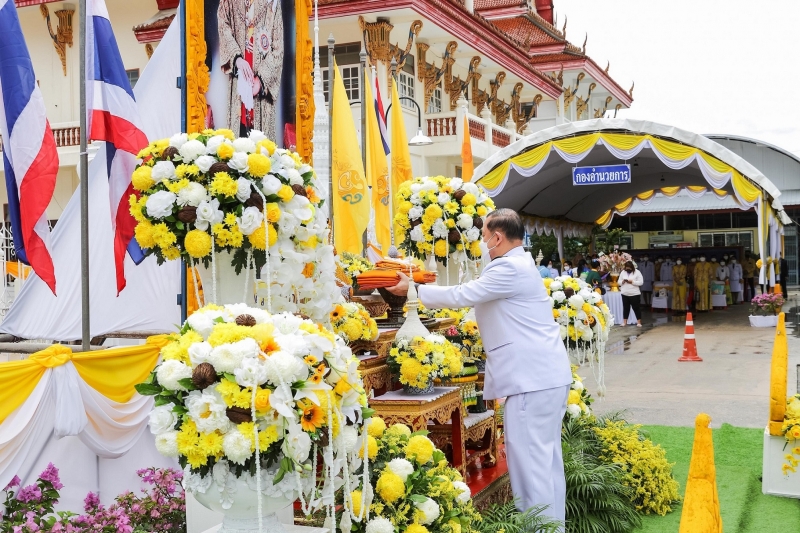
0 335 168 423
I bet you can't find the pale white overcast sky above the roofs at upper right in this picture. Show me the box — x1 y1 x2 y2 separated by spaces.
554 0 800 156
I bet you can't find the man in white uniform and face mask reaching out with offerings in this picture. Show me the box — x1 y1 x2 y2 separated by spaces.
388 209 572 521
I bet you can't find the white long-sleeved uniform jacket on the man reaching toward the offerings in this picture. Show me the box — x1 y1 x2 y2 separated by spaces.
418 246 572 400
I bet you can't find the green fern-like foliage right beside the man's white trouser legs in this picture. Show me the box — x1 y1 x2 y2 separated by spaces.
561 417 641 533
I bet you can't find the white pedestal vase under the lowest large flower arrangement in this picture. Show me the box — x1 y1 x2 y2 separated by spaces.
193 479 292 533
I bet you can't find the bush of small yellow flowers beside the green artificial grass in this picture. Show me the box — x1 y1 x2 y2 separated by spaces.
594 420 679 516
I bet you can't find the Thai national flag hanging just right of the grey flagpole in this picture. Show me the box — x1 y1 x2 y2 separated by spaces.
86 0 147 294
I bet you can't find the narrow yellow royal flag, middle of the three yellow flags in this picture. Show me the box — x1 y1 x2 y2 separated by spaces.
364 71 392 255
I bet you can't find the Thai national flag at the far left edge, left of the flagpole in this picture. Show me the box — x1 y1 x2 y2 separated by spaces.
0 0 58 294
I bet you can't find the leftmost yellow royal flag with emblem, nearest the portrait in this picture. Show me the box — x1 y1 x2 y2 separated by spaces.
331 62 369 255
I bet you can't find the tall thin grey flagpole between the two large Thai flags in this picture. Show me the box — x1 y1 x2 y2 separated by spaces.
78 0 91 352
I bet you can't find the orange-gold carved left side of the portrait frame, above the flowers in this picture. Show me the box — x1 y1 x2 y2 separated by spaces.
186 0 210 133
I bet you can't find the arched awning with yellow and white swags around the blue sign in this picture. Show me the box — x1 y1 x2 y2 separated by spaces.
475 119 789 224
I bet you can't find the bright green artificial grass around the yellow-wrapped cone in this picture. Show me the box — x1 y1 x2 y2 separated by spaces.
636 424 800 533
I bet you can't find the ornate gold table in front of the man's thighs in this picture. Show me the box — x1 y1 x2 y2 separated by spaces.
369 387 467 475
